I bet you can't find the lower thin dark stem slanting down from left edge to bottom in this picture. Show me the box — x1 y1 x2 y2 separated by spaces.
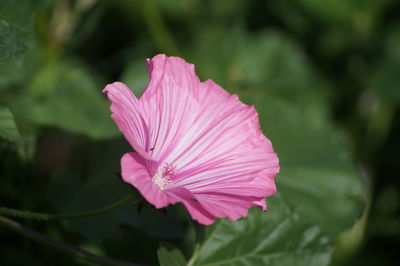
0 216 143 265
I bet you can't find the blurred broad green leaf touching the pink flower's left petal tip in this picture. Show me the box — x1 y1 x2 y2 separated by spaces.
13 62 119 139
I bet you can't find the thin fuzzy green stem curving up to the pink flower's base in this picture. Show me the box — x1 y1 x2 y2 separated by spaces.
0 196 133 220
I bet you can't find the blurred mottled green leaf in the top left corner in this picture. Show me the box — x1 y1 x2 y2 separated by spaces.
0 0 45 89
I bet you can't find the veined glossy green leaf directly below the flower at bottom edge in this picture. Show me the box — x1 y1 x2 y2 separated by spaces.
191 195 331 266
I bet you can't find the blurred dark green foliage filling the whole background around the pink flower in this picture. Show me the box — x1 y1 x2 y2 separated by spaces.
0 0 400 265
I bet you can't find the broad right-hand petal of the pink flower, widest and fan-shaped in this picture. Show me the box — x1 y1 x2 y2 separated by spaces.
169 81 279 200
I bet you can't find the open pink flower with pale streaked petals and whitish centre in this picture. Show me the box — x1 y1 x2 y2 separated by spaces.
103 55 279 225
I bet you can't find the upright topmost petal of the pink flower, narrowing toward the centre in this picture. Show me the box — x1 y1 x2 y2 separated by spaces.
140 55 200 161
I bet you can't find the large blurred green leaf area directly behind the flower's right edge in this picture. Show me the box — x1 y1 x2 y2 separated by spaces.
194 31 363 237
